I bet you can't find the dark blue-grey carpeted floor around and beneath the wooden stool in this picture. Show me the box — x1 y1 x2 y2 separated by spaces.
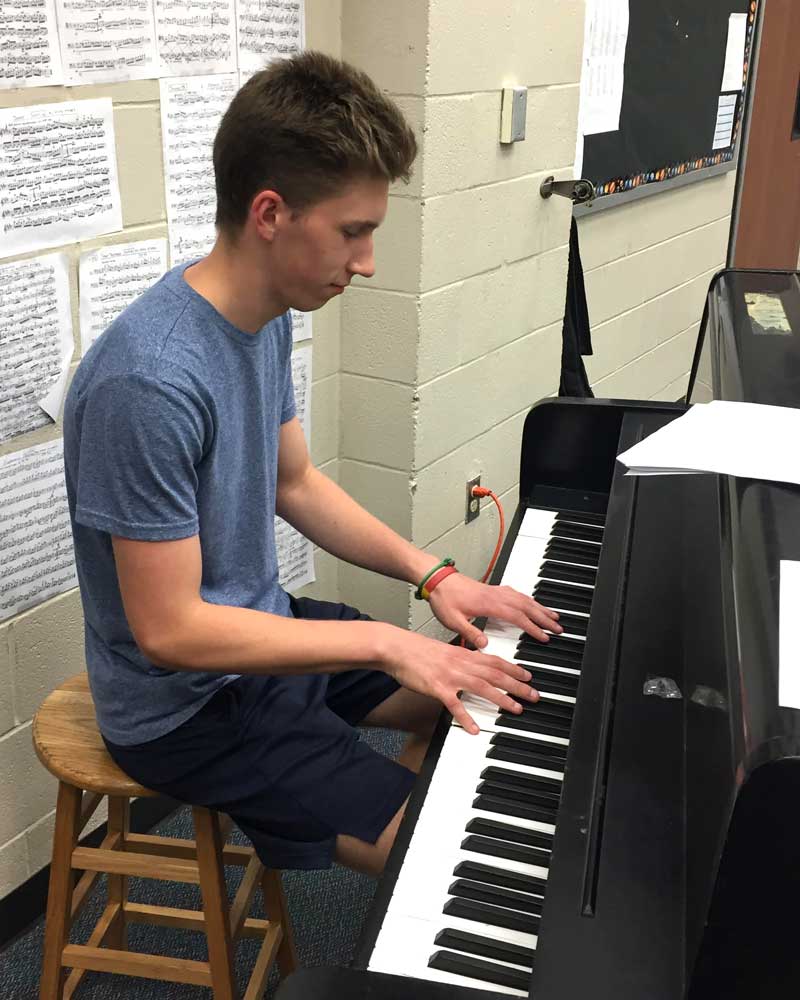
0 730 402 1000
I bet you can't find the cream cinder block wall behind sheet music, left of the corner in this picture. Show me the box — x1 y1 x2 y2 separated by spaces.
0 0 341 898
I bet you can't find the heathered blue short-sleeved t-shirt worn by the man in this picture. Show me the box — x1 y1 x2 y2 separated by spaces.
64 264 295 745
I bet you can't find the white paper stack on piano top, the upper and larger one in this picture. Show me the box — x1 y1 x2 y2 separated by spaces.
618 400 800 485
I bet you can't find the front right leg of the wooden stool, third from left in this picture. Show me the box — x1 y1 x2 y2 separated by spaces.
192 806 236 1000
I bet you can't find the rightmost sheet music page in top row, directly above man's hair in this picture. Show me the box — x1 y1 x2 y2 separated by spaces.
236 0 306 83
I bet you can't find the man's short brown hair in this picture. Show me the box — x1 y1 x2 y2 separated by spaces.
214 51 417 231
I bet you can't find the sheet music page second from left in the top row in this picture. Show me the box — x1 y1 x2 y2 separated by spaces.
56 0 158 85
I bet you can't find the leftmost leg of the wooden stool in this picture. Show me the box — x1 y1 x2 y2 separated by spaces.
39 781 83 1000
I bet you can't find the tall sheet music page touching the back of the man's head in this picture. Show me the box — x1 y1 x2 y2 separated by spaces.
161 73 238 267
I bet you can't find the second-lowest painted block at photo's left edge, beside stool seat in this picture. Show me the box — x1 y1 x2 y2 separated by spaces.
0 723 57 844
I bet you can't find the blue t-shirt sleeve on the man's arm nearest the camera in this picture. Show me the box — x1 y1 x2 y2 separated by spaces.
75 374 206 541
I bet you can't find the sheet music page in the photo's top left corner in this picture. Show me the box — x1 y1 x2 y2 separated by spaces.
0 0 64 90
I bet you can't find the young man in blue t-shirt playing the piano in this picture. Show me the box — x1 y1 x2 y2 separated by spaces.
64 52 559 872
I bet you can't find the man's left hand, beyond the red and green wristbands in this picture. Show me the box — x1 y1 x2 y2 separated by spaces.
430 573 564 649
